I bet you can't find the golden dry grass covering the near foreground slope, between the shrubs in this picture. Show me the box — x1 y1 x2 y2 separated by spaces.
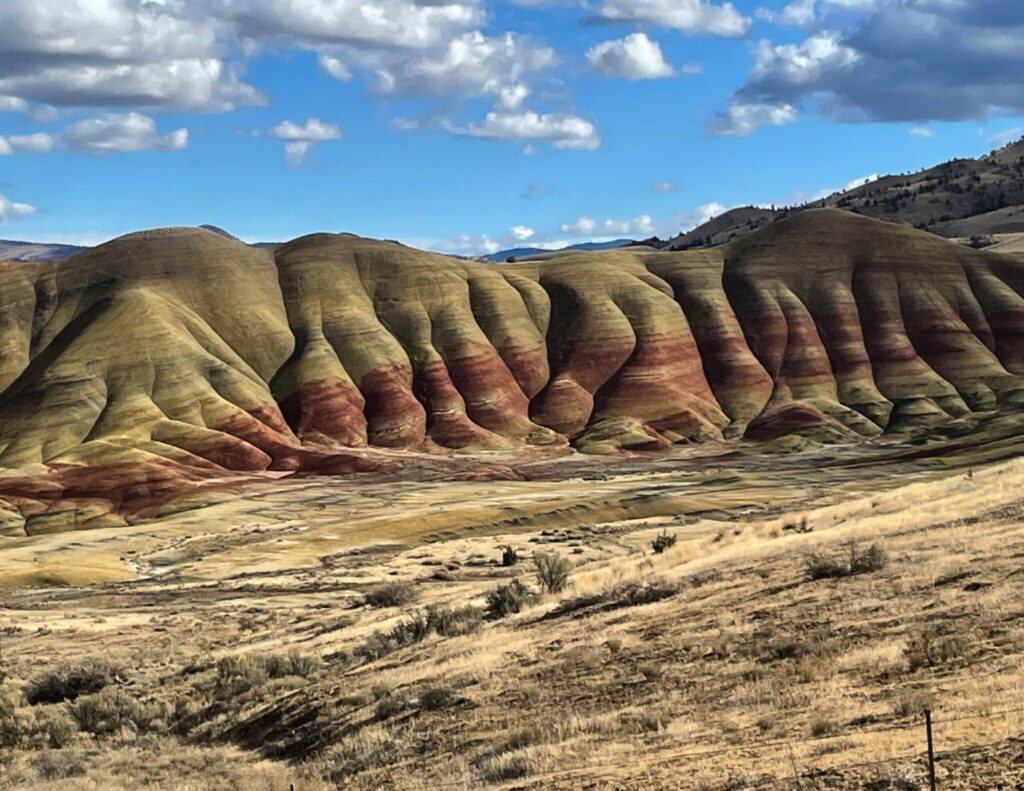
0 454 1024 791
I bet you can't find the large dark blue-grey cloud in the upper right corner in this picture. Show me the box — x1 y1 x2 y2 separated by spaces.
720 0 1024 133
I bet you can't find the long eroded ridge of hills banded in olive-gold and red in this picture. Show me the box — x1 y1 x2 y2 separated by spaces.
0 210 1024 532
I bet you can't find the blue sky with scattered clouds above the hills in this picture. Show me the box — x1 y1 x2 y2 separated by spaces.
0 0 1024 254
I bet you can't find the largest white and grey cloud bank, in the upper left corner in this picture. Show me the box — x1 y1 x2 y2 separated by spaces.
0 0 485 112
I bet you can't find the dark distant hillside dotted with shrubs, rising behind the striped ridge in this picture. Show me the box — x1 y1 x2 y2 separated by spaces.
666 134 1024 250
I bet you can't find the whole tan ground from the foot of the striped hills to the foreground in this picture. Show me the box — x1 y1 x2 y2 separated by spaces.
0 422 1024 791
